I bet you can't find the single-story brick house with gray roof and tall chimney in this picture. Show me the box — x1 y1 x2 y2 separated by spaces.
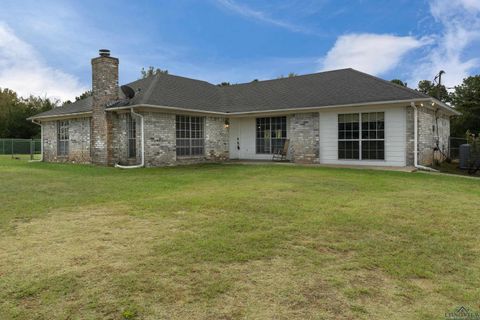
29 50 458 167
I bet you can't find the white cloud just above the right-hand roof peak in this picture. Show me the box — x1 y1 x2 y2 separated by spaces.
321 33 429 75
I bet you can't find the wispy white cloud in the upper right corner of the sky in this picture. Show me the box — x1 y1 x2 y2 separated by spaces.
409 0 480 87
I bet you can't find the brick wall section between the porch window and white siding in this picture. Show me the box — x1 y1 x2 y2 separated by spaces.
288 112 320 163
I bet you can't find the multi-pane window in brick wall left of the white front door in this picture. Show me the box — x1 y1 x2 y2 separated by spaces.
176 116 205 157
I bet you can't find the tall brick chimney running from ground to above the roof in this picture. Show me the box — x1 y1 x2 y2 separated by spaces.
90 49 118 165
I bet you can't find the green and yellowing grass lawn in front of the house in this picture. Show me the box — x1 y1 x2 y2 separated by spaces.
0 157 480 319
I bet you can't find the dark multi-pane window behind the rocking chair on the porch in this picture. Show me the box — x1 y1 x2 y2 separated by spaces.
256 117 287 154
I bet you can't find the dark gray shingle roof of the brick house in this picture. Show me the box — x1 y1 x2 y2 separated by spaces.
34 69 430 118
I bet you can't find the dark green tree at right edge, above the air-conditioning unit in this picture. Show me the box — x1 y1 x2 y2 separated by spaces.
451 75 480 137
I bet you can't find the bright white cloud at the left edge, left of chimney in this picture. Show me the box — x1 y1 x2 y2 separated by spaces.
0 23 86 100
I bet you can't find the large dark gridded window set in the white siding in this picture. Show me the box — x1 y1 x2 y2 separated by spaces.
338 112 385 160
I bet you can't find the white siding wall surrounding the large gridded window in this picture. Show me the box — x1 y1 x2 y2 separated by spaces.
320 106 406 166
